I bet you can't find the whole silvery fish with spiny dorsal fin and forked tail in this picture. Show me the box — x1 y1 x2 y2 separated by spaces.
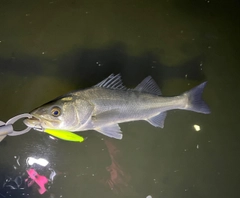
24 74 210 140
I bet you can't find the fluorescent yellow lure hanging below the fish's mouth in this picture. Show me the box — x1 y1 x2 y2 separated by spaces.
44 129 84 142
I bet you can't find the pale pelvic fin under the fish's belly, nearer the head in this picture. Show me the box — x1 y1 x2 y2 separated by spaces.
95 124 122 140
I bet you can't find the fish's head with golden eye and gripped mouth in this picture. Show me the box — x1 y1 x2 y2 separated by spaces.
24 96 77 131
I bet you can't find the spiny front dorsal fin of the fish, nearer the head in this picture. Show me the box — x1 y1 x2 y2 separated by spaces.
94 74 127 90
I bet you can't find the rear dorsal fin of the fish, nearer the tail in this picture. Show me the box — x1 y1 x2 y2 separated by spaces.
134 76 162 96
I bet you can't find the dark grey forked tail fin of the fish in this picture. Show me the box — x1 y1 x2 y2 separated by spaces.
184 82 210 114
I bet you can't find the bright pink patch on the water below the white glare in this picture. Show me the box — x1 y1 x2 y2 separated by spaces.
27 168 48 194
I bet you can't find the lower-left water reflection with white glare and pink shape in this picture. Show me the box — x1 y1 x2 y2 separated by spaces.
0 156 56 197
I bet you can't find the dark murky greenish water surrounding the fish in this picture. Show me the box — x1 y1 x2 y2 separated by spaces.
0 0 240 198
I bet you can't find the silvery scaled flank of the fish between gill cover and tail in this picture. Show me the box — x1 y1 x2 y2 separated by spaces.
79 88 182 123
